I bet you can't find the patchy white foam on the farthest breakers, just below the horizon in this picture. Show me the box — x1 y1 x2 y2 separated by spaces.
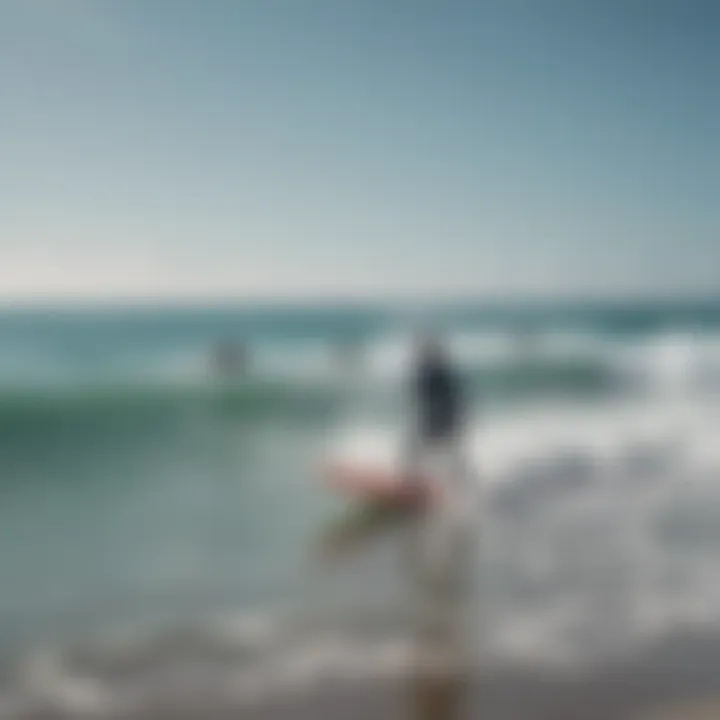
0 329 720 394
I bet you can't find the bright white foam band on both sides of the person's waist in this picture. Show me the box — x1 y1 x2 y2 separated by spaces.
328 400 720 484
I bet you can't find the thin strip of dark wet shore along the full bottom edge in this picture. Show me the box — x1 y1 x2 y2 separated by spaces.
5 630 720 720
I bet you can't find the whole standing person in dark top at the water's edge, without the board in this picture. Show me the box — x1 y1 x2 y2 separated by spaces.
408 337 477 688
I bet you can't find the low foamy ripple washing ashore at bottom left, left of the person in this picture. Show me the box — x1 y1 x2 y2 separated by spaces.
0 616 420 720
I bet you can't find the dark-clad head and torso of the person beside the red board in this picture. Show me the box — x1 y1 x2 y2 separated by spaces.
408 337 464 492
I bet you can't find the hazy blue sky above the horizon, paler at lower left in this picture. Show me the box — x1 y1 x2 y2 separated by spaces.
0 0 720 300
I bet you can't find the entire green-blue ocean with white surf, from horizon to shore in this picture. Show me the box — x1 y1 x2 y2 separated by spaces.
0 301 720 718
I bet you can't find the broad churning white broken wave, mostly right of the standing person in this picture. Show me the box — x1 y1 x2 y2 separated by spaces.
329 390 720 662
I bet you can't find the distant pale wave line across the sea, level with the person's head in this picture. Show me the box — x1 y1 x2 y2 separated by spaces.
0 330 720 386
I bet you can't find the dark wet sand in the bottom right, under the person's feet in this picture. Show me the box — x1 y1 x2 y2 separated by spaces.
238 635 720 720
